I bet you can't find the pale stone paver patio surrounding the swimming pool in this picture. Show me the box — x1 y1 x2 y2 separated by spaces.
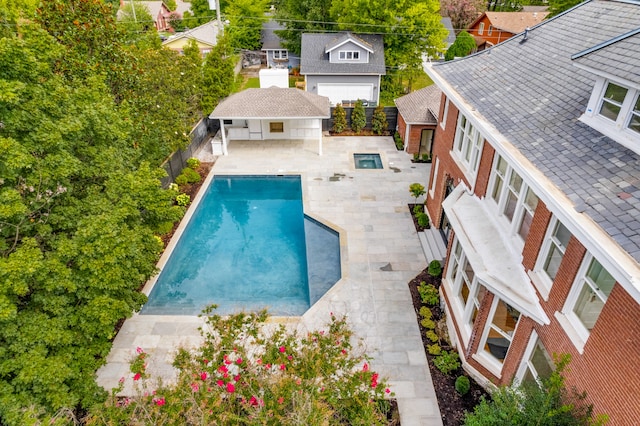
98 137 442 426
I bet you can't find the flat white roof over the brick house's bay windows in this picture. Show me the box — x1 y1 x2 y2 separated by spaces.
442 183 549 325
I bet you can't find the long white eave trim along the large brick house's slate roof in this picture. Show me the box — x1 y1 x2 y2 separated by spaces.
425 64 640 303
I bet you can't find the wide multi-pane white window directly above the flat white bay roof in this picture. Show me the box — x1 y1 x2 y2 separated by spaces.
490 154 538 245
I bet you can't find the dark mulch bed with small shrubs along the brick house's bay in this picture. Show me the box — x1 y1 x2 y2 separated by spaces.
409 269 489 426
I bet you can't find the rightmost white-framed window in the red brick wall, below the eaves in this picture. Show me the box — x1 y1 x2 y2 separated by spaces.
563 255 616 342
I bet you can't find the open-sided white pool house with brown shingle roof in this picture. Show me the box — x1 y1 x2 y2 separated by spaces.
209 87 331 155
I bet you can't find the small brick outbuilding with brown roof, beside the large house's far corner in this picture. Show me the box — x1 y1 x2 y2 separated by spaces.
394 84 442 154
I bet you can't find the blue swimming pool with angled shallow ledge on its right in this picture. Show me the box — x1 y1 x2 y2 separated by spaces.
141 176 340 316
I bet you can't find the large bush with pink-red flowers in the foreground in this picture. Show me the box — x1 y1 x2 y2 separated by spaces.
87 307 393 425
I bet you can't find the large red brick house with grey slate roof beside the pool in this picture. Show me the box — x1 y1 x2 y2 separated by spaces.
426 0 640 425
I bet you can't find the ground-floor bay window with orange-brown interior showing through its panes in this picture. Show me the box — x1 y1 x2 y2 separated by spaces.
481 295 520 363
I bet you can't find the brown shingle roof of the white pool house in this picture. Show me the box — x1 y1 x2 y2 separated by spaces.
209 87 331 119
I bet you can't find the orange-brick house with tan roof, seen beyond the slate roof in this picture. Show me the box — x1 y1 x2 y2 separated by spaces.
467 12 549 50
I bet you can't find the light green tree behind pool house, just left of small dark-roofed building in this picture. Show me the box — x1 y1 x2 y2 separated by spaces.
225 0 268 51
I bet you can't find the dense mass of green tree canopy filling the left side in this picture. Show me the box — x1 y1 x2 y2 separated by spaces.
0 0 218 425
